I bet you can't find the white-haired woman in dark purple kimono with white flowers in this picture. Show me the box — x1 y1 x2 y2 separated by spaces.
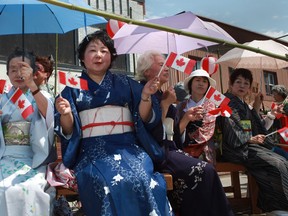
136 50 234 216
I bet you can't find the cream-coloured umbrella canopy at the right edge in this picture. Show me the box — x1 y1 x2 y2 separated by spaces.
216 40 288 70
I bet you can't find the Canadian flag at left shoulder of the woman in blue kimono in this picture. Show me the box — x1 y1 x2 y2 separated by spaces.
58 71 88 90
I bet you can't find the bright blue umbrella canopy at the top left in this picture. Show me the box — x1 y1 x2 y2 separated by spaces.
0 0 107 35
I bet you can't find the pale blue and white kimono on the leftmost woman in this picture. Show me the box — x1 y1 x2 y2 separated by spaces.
0 88 56 216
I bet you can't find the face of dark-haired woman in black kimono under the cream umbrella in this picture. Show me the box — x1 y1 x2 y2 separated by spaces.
230 76 251 99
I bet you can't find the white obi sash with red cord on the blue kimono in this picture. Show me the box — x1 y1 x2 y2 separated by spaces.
79 105 134 138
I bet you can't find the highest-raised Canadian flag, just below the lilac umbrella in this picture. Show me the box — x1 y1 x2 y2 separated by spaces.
166 52 196 75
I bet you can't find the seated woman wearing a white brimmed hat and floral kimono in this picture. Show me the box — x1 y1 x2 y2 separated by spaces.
177 69 216 164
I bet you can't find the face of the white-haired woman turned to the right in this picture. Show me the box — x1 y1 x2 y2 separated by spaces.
145 55 169 84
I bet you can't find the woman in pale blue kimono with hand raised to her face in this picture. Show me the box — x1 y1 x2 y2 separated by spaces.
0 49 56 216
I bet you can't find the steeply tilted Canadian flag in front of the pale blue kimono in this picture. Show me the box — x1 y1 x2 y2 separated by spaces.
10 88 34 119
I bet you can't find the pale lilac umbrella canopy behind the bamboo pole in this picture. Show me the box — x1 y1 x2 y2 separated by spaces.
113 12 236 54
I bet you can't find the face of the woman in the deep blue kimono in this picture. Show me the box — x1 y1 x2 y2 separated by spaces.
83 40 111 75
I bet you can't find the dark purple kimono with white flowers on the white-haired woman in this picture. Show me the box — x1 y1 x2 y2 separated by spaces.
153 92 234 216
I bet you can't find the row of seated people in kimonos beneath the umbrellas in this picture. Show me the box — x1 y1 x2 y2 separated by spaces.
0 30 288 216
